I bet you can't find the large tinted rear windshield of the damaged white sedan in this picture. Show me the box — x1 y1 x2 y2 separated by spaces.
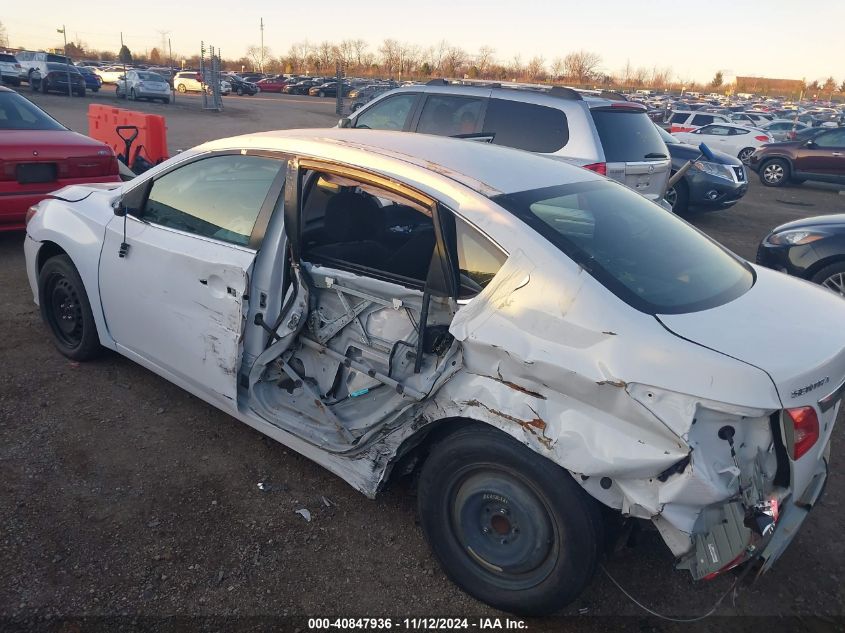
492 180 754 314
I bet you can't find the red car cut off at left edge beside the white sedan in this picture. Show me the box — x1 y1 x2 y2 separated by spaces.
0 86 120 231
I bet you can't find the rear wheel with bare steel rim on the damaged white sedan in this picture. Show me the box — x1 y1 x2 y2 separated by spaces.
418 424 601 615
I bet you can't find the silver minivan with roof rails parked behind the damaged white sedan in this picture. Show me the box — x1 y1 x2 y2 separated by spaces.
340 79 671 201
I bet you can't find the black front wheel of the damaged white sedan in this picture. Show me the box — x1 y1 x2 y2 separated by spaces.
38 255 102 361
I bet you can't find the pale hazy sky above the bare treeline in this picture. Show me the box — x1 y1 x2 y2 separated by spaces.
0 0 845 83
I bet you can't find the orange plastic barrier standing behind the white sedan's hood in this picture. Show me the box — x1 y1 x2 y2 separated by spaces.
88 103 170 167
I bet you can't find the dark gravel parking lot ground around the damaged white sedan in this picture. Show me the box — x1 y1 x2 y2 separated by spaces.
0 89 845 630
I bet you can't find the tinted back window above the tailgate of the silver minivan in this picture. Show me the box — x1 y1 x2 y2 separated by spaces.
590 109 669 163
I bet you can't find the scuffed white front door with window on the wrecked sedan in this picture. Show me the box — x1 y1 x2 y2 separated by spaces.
100 153 285 408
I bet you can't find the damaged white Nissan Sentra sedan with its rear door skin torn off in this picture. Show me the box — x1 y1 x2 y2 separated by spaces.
25 129 845 614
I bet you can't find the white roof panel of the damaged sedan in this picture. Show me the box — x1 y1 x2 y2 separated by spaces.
195 128 601 196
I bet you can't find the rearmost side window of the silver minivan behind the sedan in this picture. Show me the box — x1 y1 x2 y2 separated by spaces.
483 99 569 153
